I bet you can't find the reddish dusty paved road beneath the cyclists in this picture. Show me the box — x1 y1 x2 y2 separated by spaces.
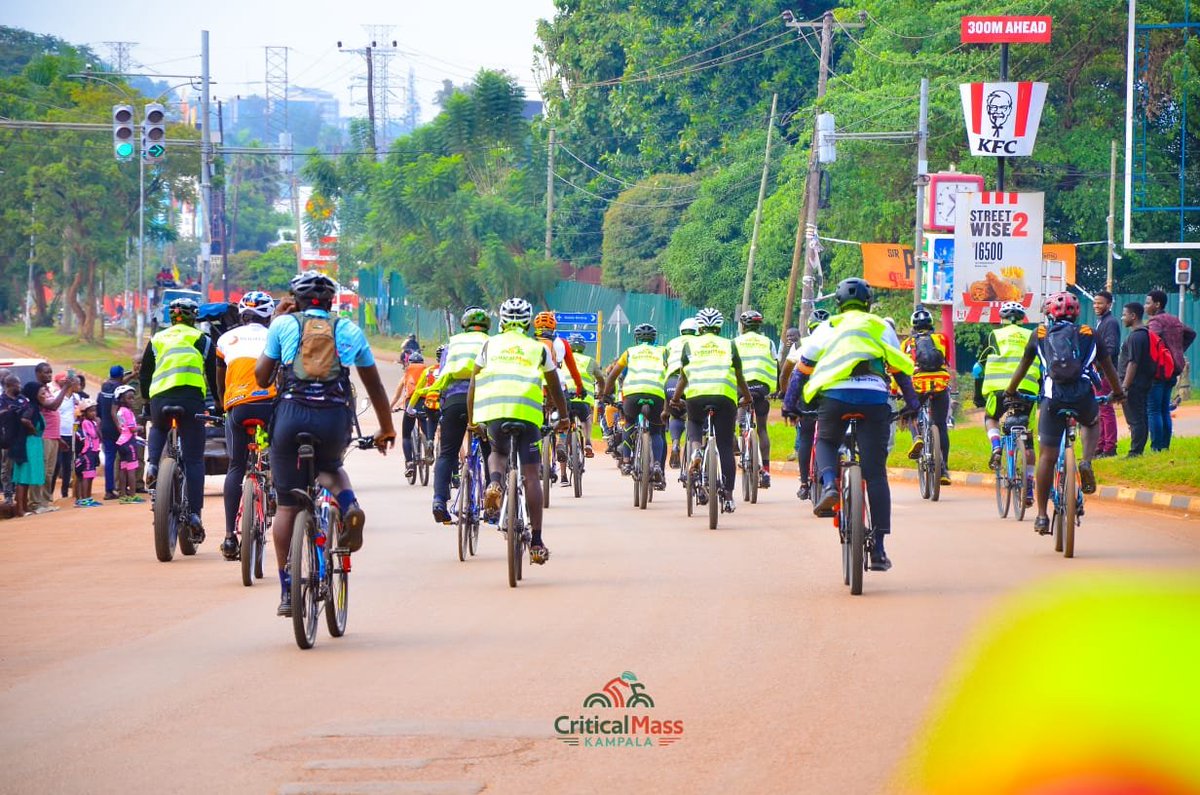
0 405 1200 794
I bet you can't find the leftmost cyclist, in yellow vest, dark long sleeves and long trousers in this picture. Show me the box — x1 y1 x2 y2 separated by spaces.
138 298 217 544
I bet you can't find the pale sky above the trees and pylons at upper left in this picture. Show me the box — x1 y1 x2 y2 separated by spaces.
2 0 554 121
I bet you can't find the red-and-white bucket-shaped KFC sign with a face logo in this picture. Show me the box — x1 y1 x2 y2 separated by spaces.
959 82 1046 157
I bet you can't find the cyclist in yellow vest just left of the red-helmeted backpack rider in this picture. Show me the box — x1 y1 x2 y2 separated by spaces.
972 301 1042 506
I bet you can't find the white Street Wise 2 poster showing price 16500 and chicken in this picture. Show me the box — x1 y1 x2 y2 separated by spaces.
954 192 1045 323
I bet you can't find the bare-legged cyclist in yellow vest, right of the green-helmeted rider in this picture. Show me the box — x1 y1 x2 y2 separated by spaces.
467 298 568 566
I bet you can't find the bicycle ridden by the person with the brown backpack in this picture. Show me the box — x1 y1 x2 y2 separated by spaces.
288 434 374 648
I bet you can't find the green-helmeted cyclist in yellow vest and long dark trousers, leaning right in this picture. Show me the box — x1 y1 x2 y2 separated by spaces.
431 306 492 524
